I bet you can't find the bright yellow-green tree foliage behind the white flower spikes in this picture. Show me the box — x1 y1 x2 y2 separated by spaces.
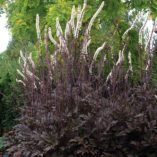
0 0 156 62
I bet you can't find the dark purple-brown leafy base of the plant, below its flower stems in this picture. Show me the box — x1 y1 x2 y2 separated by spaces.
6 82 157 157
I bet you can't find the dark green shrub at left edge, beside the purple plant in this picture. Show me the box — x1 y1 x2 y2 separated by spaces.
0 54 23 135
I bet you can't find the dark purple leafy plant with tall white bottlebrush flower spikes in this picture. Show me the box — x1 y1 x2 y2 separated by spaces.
6 3 157 157
